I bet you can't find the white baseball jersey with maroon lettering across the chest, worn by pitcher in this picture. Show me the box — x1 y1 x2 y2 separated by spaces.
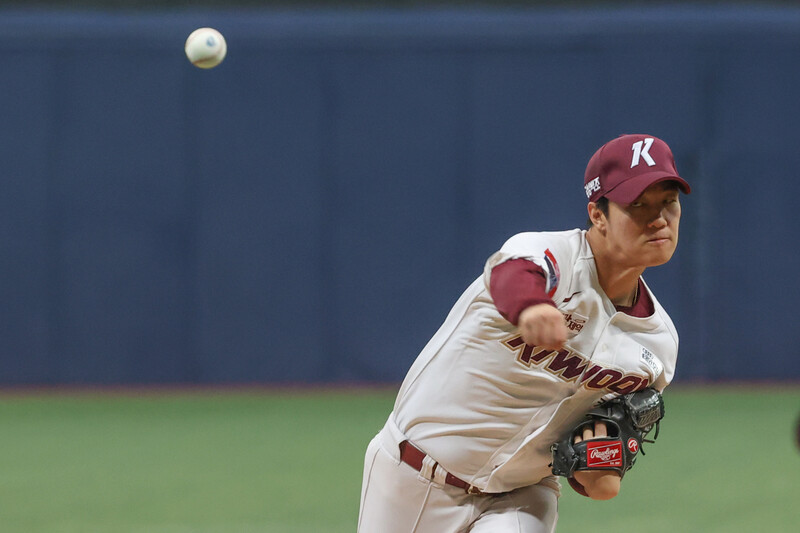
390 229 678 492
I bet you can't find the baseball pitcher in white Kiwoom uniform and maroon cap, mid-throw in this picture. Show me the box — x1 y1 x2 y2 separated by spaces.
358 135 690 533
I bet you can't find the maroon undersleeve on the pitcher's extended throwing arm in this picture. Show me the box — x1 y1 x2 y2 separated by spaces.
489 259 555 326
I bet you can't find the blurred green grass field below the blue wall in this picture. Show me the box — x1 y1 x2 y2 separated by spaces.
0 387 800 533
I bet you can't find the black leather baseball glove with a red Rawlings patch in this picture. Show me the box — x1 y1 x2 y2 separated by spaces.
550 388 664 480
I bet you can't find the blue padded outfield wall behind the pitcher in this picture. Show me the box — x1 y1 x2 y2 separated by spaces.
0 8 800 385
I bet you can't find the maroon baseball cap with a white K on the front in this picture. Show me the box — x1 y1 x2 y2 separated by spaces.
583 134 692 205
